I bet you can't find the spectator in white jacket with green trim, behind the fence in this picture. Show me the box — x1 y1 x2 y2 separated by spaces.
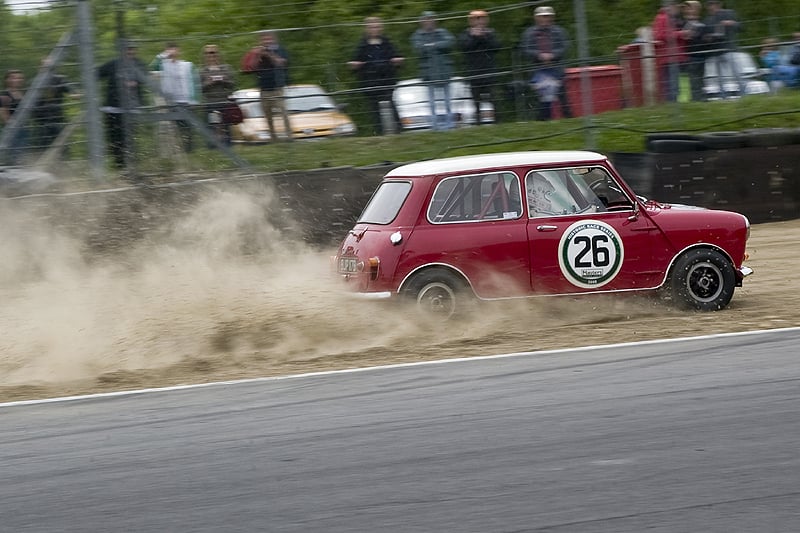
150 43 199 152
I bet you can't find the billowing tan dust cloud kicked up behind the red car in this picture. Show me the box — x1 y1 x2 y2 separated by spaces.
0 186 512 389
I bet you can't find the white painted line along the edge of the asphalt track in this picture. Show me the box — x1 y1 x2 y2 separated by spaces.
0 327 800 408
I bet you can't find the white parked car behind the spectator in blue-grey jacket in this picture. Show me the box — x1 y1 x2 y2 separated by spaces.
392 78 494 130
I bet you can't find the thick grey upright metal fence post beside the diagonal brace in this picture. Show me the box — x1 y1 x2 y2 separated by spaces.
78 0 105 182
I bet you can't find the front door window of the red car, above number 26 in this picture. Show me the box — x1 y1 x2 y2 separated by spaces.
525 167 633 217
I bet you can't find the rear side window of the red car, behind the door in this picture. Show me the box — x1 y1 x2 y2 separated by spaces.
427 172 522 220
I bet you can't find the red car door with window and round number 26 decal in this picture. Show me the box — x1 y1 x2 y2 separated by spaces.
525 167 668 294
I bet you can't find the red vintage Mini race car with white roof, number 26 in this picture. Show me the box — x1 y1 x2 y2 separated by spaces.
334 151 752 317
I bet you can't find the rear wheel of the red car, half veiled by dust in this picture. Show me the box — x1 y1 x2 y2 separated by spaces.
403 268 472 320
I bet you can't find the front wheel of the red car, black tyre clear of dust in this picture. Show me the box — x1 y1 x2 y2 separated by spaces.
670 250 736 311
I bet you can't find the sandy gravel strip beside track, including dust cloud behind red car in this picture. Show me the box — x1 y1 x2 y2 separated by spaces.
0 190 800 401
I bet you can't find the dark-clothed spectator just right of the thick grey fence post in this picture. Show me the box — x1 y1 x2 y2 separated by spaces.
97 42 147 168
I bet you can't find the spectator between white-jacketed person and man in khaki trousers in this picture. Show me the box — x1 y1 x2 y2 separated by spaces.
200 44 236 144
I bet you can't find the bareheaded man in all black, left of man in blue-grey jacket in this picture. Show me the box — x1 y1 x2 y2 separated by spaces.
347 17 405 135
